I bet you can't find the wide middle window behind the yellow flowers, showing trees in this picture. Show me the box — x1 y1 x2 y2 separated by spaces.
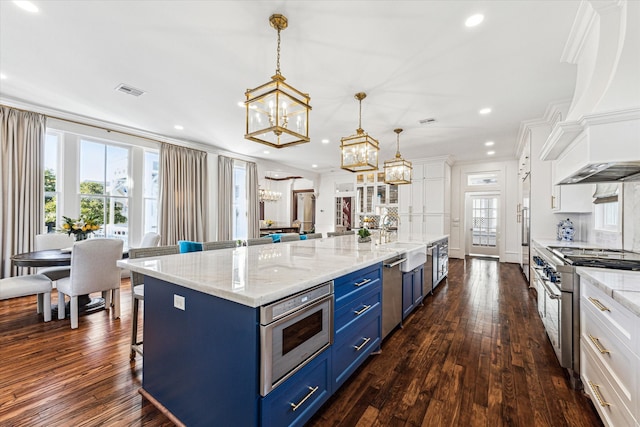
79 139 129 245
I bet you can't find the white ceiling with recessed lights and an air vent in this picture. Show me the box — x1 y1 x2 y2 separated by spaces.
0 0 579 172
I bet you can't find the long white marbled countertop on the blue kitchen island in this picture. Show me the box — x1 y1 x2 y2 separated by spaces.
118 235 426 307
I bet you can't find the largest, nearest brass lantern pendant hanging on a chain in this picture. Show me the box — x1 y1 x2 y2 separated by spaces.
244 14 311 148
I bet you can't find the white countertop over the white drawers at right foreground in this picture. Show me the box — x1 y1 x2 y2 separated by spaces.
576 267 640 317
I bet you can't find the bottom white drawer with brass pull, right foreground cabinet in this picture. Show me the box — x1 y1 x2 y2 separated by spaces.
580 343 637 427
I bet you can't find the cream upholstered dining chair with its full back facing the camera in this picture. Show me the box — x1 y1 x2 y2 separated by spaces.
56 239 124 329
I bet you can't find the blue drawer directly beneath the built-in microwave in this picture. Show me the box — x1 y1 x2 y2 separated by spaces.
261 348 331 427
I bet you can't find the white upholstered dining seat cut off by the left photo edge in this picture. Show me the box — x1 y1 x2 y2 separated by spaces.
0 274 53 322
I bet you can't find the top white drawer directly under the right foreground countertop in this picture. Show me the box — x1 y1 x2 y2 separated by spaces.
580 277 638 351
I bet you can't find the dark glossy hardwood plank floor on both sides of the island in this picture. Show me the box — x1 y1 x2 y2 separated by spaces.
0 259 601 427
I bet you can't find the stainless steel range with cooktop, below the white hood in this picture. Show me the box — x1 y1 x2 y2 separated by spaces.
532 243 640 388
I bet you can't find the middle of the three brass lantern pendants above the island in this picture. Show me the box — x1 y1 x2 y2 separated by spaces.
340 92 379 172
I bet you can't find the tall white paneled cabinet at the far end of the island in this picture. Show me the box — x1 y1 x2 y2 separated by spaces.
398 157 452 236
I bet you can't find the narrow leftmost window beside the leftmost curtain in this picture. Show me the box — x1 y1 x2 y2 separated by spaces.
44 132 60 233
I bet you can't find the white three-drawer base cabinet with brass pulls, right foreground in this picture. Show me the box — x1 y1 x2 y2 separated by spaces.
580 276 640 426
